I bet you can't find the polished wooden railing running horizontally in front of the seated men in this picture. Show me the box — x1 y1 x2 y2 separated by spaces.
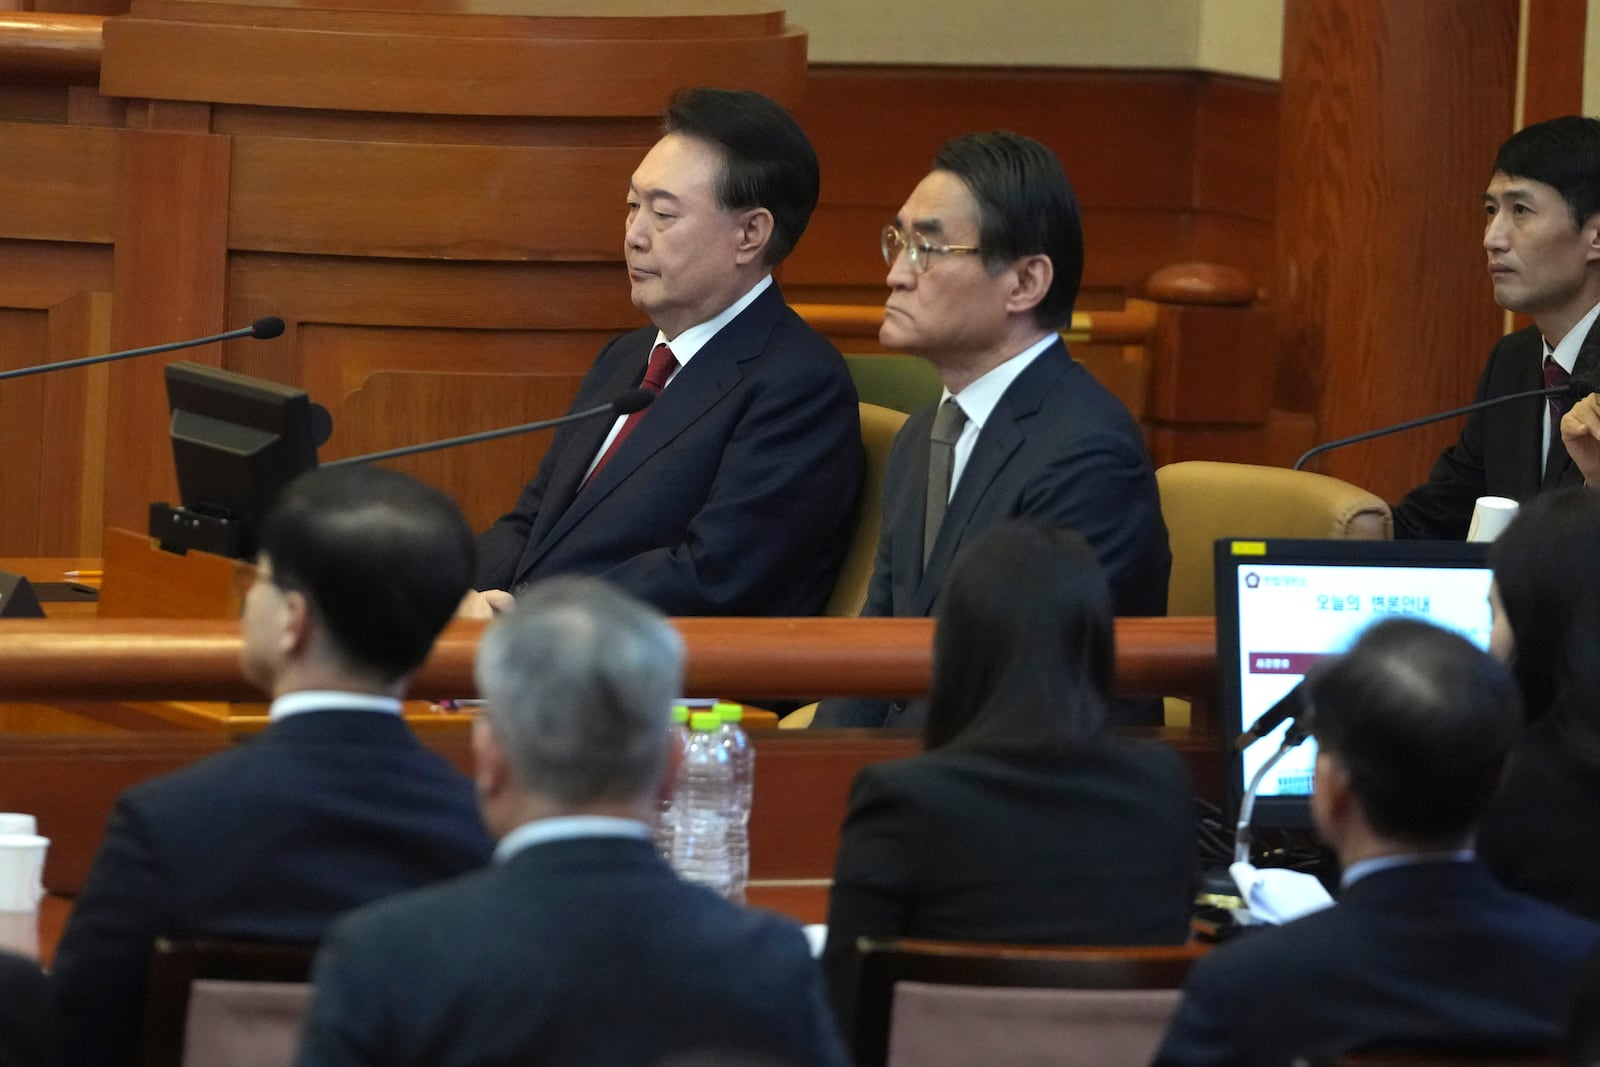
0 617 1216 702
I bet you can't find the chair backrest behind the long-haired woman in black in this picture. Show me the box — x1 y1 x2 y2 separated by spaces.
851 937 1206 1067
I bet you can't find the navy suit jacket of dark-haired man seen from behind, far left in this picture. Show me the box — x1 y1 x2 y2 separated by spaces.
53 710 491 1067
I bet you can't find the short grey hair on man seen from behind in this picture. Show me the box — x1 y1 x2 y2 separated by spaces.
477 577 683 805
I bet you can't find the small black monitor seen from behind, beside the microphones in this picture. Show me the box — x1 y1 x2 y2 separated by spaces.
150 360 331 558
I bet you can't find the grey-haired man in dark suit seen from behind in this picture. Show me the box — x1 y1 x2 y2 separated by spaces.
299 577 848 1067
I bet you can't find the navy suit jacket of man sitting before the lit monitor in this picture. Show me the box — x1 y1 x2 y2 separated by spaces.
1155 862 1600 1067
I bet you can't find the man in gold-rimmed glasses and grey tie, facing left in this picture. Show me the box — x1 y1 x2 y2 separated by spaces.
814 133 1171 726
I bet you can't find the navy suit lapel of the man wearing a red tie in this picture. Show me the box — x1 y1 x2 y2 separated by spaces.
522 283 784 569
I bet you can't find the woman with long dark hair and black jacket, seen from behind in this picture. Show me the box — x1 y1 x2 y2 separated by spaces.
824 522 1195 1008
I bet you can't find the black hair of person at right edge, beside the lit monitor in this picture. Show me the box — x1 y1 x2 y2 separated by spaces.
1490 486 1600 768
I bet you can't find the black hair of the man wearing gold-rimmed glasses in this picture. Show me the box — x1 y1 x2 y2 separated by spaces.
933 130 1083 330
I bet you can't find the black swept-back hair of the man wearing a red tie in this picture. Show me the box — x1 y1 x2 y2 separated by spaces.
662 88 821 267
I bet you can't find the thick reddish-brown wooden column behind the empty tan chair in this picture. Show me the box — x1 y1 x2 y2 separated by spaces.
1275 0 1518 501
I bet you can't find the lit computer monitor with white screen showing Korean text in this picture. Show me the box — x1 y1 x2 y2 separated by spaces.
1216 539 1490 827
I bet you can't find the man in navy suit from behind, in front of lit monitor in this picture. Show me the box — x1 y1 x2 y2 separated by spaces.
1155 619 1600 1065
